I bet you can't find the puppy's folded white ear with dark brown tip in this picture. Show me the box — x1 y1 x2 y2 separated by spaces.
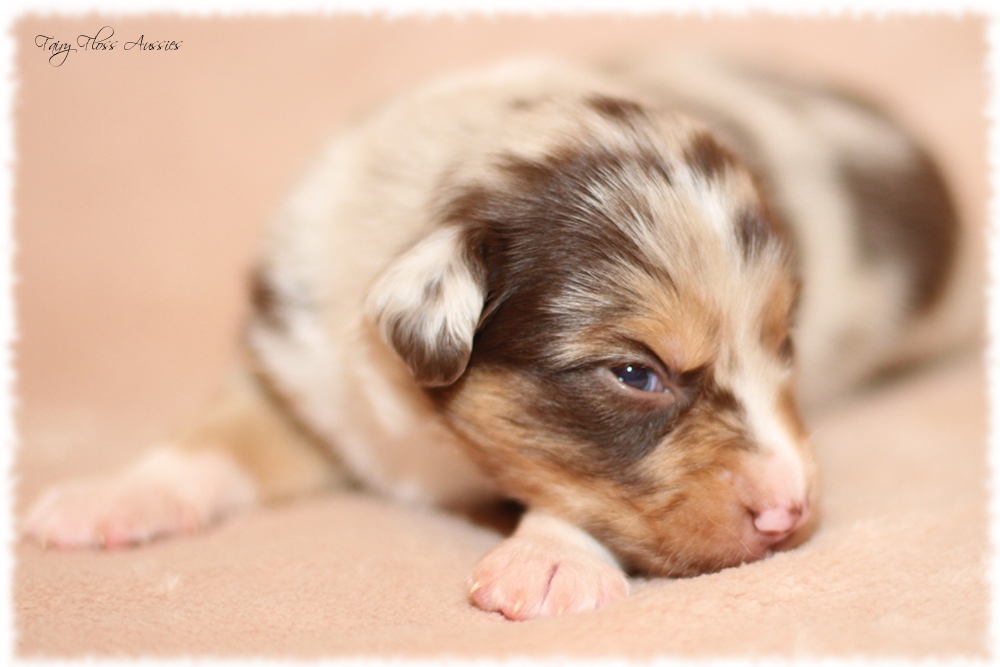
365 226 486 387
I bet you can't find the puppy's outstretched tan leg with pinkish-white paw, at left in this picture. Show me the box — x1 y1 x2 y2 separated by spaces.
24 371 340 547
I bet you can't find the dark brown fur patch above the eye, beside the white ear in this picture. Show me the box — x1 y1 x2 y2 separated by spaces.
444 144 672 366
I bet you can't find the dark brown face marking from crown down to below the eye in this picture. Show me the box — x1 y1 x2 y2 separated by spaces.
432 142 708 483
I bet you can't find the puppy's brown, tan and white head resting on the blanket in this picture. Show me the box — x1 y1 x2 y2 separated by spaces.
368 97 816 575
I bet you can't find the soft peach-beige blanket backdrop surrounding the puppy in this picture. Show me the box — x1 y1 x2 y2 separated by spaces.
13 15 987 655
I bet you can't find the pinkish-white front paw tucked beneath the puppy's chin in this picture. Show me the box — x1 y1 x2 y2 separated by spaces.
469 511 628 621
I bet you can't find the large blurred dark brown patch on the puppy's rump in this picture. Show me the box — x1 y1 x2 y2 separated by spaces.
840 144 958 314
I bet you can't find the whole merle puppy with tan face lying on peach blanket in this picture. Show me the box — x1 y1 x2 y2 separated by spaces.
25 59 967 619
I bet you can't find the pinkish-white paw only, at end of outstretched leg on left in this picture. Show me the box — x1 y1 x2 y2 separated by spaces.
23 449 255 547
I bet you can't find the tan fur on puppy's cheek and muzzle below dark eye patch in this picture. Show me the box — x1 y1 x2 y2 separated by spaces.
438 369 788 576
